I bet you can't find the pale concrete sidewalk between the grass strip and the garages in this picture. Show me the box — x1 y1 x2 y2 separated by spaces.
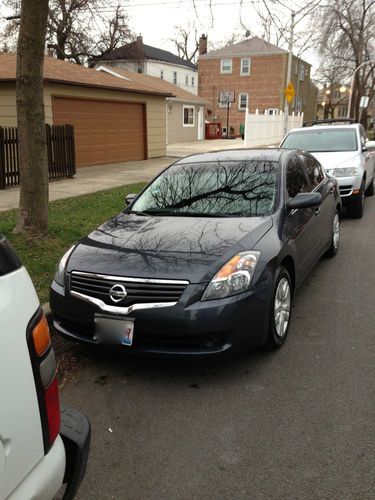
0 139 248 212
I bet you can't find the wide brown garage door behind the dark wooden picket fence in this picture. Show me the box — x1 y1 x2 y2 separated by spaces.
52 97 146 167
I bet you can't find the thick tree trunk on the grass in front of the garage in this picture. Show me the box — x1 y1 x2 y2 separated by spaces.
16 0 48 235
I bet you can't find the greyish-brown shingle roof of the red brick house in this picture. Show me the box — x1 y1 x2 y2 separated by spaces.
199 36 287 59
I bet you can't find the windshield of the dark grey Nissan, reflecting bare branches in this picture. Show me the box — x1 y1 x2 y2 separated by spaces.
131 160 279 217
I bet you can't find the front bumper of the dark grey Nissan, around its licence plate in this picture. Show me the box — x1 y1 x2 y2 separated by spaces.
50 281 269 357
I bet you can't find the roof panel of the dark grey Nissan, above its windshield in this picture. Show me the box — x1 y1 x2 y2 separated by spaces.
174 148 301 165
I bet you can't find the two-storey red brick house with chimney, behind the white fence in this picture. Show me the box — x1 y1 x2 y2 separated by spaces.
198 35 318 136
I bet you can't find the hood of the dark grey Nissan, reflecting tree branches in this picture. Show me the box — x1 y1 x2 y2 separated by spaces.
66 213 272 283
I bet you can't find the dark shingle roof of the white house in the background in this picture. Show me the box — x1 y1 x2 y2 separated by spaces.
102 42 197 69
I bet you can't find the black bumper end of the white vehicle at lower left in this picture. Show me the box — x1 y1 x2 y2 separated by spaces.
60 408 91 500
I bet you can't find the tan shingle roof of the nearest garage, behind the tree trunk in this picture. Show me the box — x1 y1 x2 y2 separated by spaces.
0 53 174 97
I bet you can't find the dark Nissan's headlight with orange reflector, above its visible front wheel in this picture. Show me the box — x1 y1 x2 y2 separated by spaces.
202 250 260 300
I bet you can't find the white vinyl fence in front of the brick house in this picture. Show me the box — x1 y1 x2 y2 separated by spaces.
244 110 303 148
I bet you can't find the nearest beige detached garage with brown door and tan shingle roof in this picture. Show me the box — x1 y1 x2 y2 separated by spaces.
0 53 173 167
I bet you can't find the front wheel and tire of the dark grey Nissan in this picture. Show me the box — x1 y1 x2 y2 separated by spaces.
264 267 293 351
